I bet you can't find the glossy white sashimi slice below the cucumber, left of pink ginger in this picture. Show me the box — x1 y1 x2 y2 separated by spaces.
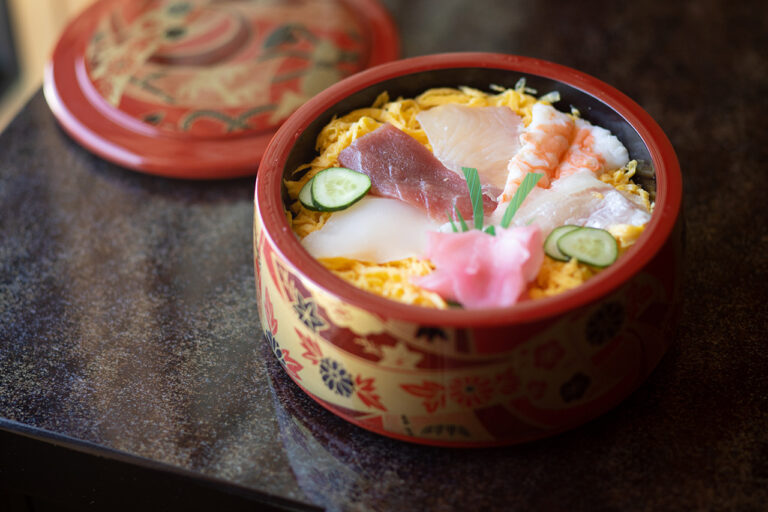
301 196 440 263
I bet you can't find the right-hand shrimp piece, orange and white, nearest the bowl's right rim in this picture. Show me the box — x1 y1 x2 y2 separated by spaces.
555 119 629 178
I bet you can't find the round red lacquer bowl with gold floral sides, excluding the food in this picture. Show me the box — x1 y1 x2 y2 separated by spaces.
254 53 682 446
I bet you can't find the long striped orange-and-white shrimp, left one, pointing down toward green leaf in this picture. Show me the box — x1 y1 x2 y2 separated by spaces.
497 103 575 210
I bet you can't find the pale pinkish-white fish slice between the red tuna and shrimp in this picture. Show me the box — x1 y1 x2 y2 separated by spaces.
416 104 523 195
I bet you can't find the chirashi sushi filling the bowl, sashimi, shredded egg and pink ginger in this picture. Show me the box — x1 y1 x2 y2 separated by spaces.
285 81 653 308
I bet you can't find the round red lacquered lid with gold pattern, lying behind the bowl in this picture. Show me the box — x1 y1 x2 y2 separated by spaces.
44 0 399 179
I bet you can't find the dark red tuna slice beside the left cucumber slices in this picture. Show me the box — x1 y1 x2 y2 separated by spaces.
339 124 496 221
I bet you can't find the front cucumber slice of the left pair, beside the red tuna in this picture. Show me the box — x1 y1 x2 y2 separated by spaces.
312 167 371 212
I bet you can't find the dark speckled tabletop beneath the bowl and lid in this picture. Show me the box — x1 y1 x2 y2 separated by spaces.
0 0 768 511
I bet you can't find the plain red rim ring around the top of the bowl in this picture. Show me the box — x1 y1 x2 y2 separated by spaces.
255 52 682 327
